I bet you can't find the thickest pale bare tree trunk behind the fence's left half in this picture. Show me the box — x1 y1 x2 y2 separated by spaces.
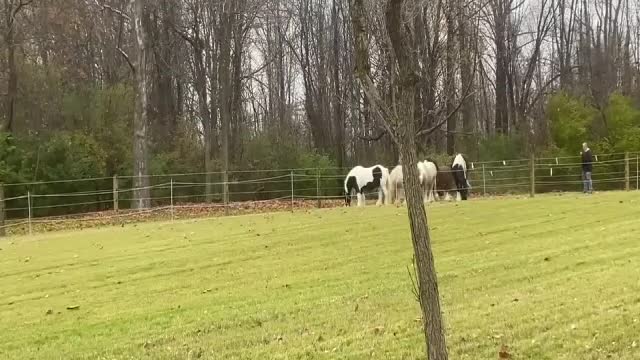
132 0 151 209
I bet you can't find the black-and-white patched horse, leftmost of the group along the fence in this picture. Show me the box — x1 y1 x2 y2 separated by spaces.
344 165 389 206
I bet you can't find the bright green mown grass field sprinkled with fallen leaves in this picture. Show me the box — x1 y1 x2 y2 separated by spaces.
0 193 640 360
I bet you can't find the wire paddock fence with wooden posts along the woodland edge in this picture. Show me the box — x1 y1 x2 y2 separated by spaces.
0 152 640 236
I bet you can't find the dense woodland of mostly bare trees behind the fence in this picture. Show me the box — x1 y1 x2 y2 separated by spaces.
0 0 640 207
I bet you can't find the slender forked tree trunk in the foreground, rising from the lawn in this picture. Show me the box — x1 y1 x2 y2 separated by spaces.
351 0 448 360
